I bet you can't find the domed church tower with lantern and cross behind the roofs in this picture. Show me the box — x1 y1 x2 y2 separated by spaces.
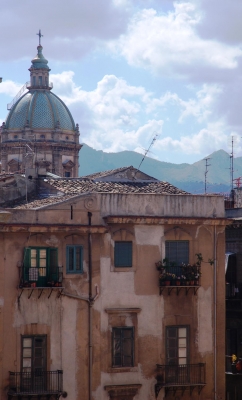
0 32 82 177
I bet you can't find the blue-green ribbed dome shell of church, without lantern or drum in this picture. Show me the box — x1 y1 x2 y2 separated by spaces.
6 90 75 131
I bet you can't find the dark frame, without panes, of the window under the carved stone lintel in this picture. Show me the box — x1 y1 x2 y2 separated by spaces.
112 326 135 368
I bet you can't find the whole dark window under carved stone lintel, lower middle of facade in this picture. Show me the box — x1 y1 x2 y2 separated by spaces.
112 327 134 367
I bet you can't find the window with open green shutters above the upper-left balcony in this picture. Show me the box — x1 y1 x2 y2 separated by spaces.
23 247 61 287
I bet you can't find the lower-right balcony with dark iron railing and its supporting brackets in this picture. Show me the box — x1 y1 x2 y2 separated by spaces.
155 363 206 397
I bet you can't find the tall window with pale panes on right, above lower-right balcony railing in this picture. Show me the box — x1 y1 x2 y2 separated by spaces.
166 326 188 365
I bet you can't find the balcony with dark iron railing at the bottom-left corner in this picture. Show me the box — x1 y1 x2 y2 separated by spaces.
8 370 66 400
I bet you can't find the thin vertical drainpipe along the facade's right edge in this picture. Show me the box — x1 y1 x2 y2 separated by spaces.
213 225 217 400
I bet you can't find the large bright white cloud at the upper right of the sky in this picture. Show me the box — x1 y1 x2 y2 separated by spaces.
110 2 242 76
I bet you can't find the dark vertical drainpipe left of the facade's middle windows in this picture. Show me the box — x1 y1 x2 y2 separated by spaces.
87 212 93 400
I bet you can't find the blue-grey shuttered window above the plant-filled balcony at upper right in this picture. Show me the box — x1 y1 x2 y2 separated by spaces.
166 240 189 265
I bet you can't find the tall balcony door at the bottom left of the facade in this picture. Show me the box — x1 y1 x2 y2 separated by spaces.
21 335 47 392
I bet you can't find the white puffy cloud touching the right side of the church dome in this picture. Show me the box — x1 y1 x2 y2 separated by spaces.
51 71 163 151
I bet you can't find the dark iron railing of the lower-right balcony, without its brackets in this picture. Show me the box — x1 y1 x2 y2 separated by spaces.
157 363 206 386
